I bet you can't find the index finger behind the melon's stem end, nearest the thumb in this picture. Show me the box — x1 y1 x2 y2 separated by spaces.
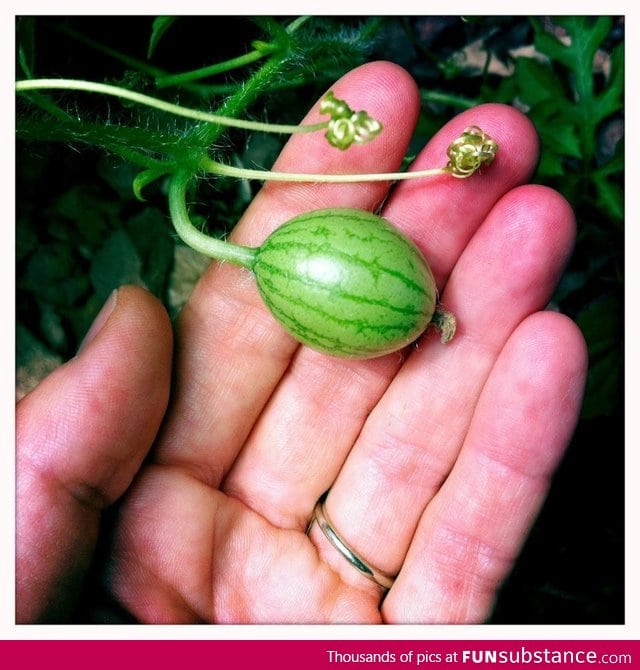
157 63 418 486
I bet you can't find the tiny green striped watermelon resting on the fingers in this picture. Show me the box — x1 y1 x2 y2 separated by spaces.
253 209 437 358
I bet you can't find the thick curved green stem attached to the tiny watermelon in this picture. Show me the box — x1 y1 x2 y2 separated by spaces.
169 172 258 269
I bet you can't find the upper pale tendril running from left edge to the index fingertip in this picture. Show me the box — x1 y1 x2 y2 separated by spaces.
16 79 328 134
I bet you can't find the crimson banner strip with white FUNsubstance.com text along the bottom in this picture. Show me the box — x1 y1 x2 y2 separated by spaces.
0 640 640 670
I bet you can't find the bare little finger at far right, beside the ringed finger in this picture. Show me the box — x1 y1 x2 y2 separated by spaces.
383 312 587 623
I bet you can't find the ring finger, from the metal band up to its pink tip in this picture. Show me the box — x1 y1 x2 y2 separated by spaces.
312 186 574 592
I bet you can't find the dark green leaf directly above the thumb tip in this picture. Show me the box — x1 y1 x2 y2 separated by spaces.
89 230 145 301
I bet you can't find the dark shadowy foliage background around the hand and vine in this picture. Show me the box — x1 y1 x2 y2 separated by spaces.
16 16 624 624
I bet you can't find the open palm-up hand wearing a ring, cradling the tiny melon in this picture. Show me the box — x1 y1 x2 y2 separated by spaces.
16 62 587 623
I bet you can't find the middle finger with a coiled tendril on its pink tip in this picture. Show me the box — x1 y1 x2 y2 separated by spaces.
220 105 540 528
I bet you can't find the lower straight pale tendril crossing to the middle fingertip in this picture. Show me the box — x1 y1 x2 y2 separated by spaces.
200 158 450 184
